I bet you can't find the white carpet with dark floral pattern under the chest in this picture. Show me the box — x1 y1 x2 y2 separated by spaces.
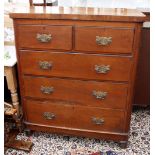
5 108 150 155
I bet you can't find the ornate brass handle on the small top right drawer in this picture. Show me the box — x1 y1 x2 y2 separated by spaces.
96 36 112 46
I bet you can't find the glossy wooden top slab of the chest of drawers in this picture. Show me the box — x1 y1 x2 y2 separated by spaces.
10 6 145 22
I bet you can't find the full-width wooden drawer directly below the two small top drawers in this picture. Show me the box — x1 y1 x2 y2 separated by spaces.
20 51 132 81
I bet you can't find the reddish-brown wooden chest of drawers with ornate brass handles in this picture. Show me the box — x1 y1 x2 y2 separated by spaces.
10 7 145 147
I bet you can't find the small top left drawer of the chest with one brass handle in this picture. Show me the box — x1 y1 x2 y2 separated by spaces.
17 25 72 50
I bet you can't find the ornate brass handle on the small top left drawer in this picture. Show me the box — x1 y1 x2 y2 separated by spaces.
36 33 52 43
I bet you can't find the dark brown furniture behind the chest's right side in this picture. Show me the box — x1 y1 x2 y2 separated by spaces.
133 12 150 107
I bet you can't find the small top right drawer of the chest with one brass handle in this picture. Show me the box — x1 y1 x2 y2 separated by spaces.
75 27 134 53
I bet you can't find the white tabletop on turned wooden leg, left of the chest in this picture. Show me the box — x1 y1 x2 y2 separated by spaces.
4 46 17 67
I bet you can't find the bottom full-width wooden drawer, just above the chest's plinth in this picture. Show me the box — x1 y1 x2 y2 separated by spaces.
24 100 125 132
